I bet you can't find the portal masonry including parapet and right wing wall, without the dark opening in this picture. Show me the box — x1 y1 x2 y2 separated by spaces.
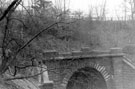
40 46 135 89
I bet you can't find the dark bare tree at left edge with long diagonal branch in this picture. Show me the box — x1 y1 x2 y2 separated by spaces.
0 0 59 75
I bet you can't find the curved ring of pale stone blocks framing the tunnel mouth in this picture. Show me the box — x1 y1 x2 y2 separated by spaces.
61 62 111 89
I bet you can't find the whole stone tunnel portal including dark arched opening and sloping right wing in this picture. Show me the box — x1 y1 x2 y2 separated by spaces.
38 47 135 89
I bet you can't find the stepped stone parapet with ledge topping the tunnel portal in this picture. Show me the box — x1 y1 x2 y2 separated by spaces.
43 47 124 61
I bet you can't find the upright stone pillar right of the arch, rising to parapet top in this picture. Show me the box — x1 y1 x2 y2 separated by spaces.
111 48 123 89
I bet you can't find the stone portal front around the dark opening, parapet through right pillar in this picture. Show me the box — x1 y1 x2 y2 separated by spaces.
43 48 123 89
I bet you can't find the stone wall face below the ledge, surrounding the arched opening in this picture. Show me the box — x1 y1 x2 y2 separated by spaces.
44 57 123 89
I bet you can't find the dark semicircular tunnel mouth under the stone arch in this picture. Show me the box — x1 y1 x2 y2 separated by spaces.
66 67 107 89
